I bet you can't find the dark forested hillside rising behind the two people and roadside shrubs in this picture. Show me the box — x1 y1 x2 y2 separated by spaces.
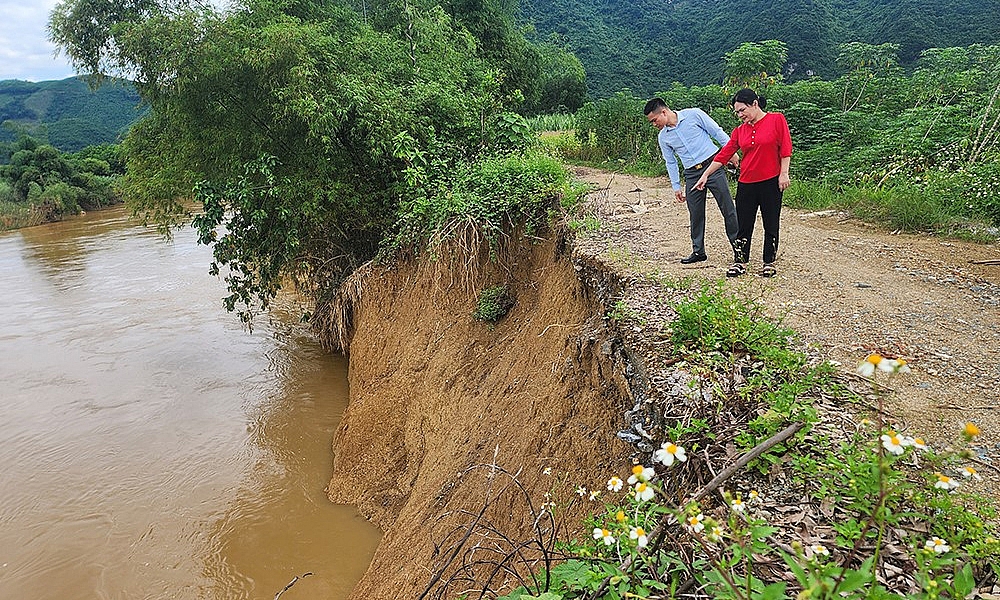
521 0 1000 97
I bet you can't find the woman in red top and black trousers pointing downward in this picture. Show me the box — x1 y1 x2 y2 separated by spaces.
694 89 792 277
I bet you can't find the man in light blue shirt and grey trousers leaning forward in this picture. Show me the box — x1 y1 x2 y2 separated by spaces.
643 98 739 265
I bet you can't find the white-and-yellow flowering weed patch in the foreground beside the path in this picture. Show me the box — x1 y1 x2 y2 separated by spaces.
482 355 1000 600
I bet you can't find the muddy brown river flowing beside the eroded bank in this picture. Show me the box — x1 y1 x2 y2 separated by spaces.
0 209 380 600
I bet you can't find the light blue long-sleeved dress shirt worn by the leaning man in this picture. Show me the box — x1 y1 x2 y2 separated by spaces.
657 108 729 192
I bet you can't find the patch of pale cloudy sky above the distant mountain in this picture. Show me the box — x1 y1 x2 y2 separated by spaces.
0 0 74 81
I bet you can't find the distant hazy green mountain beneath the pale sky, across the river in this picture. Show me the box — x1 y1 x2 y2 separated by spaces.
0 77 145 152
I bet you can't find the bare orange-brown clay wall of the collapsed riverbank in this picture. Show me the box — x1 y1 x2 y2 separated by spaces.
327 240 631 600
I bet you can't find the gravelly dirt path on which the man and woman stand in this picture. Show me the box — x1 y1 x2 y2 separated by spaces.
574 167 1000 472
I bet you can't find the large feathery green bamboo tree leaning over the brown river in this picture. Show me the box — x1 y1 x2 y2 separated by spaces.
51 0 503 320
